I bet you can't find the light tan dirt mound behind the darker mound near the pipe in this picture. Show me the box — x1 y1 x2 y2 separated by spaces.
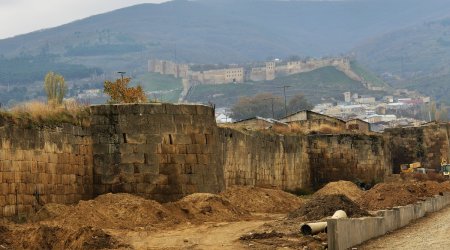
314 181 364 201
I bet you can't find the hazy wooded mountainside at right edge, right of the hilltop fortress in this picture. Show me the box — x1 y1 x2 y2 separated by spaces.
354 18 450 104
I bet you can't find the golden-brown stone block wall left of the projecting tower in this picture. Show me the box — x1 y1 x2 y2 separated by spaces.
0 125 93 217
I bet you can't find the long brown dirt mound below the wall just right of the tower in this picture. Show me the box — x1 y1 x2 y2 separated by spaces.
220 186 303 213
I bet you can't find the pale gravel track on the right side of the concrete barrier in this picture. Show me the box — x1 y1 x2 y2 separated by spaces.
358 207 450 250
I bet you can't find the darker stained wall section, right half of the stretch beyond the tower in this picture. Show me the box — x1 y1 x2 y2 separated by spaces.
308 134 391 186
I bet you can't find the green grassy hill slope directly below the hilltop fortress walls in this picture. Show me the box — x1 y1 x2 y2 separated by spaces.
188 66 384 107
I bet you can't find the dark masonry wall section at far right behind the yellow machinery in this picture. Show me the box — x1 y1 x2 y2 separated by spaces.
384 124 450 173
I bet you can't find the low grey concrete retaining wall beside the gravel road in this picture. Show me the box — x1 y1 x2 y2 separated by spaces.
327 193 450 250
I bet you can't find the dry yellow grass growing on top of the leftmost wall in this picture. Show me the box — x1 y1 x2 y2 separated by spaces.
0 101 90 127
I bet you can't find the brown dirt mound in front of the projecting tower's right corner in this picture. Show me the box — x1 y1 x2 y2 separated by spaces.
164 193 250 223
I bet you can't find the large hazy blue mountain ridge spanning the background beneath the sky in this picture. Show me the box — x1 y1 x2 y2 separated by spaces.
0 0 450 85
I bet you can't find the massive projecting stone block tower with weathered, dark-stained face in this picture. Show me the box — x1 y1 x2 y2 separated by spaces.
91 104 223 202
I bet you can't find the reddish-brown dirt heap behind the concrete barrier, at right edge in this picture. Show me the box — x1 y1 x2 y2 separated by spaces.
357 181 448 210
